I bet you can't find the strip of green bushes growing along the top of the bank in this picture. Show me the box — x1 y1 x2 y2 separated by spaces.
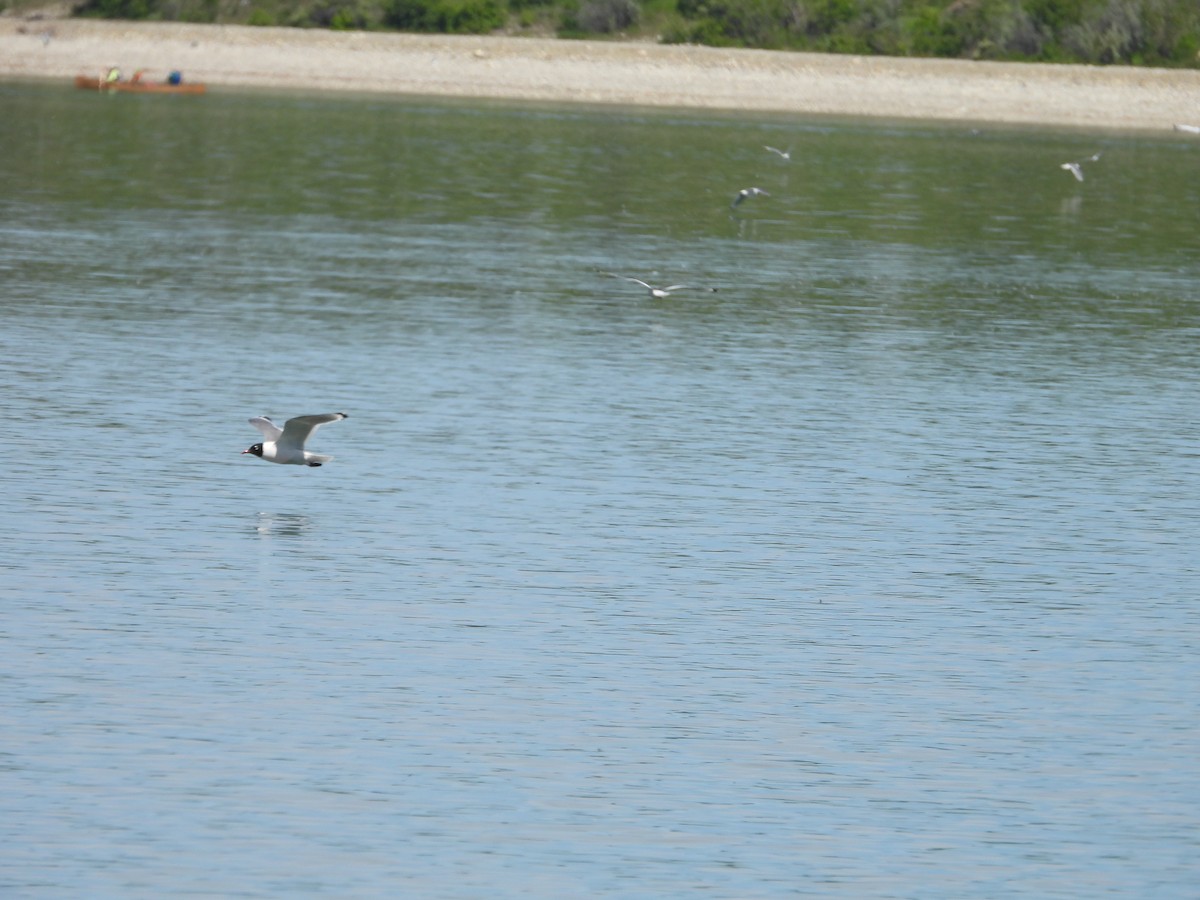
68 0 1200 68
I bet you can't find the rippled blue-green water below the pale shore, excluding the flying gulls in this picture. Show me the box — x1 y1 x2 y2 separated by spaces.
0 84 1200 898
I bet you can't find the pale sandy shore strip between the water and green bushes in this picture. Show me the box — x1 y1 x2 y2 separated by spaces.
0 18 1200 130
